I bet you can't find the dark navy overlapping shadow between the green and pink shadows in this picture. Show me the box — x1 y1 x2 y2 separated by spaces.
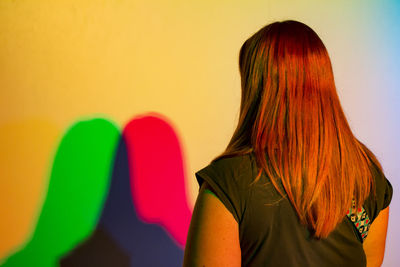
60 138 183 266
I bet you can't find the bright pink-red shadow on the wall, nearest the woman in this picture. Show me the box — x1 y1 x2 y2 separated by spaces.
123 113 192 247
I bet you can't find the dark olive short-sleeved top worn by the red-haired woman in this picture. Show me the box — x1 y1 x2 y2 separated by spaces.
196 154 392 267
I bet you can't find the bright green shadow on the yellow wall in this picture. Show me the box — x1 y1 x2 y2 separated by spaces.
2 119 120 267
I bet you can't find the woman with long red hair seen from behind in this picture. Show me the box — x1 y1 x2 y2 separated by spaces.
184 21 392 267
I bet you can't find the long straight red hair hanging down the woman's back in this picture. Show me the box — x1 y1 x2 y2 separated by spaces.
214 21 382 238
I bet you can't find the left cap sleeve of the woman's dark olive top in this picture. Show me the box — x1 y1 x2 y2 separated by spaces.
195 158 249 223
